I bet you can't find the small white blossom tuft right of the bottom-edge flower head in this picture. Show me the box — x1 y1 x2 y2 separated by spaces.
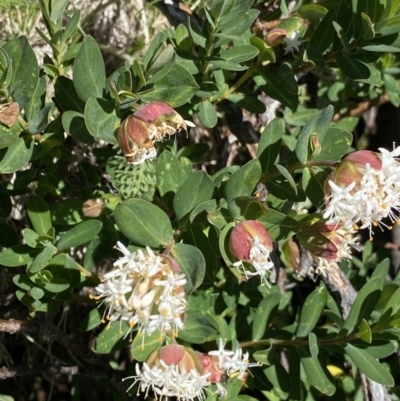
208 338 259 380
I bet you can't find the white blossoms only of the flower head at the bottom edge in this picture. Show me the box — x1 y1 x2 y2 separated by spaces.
127 360 211 401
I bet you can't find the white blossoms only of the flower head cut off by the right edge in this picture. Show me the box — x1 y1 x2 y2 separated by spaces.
323 147 400 233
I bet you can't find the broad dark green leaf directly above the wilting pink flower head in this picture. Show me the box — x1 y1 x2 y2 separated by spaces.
140 63 199 107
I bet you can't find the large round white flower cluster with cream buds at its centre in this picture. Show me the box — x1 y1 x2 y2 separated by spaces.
96 242 187 334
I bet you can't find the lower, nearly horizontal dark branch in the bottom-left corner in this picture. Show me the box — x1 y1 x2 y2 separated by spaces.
0 364 123 380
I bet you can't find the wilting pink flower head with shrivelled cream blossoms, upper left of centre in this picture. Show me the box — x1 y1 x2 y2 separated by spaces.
118 101 194 164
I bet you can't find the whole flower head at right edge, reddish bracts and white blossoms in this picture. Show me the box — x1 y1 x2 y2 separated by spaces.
323 148 400 233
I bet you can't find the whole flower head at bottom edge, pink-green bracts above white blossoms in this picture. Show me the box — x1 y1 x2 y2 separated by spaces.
126 344 211 401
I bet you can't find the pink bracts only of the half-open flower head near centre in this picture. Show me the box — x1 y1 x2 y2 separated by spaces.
229 220 272 261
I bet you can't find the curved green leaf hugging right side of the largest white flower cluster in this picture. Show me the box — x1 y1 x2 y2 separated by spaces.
171 243 206 293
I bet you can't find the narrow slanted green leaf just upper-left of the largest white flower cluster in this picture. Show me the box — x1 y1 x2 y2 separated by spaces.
57 219 103 251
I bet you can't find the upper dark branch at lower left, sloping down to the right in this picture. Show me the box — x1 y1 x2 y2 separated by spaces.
0 319 110 371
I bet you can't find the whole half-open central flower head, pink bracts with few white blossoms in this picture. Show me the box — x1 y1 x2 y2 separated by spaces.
229 220 274 284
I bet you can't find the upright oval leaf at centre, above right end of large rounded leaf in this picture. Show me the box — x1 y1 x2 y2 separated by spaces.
173 171 214 220
